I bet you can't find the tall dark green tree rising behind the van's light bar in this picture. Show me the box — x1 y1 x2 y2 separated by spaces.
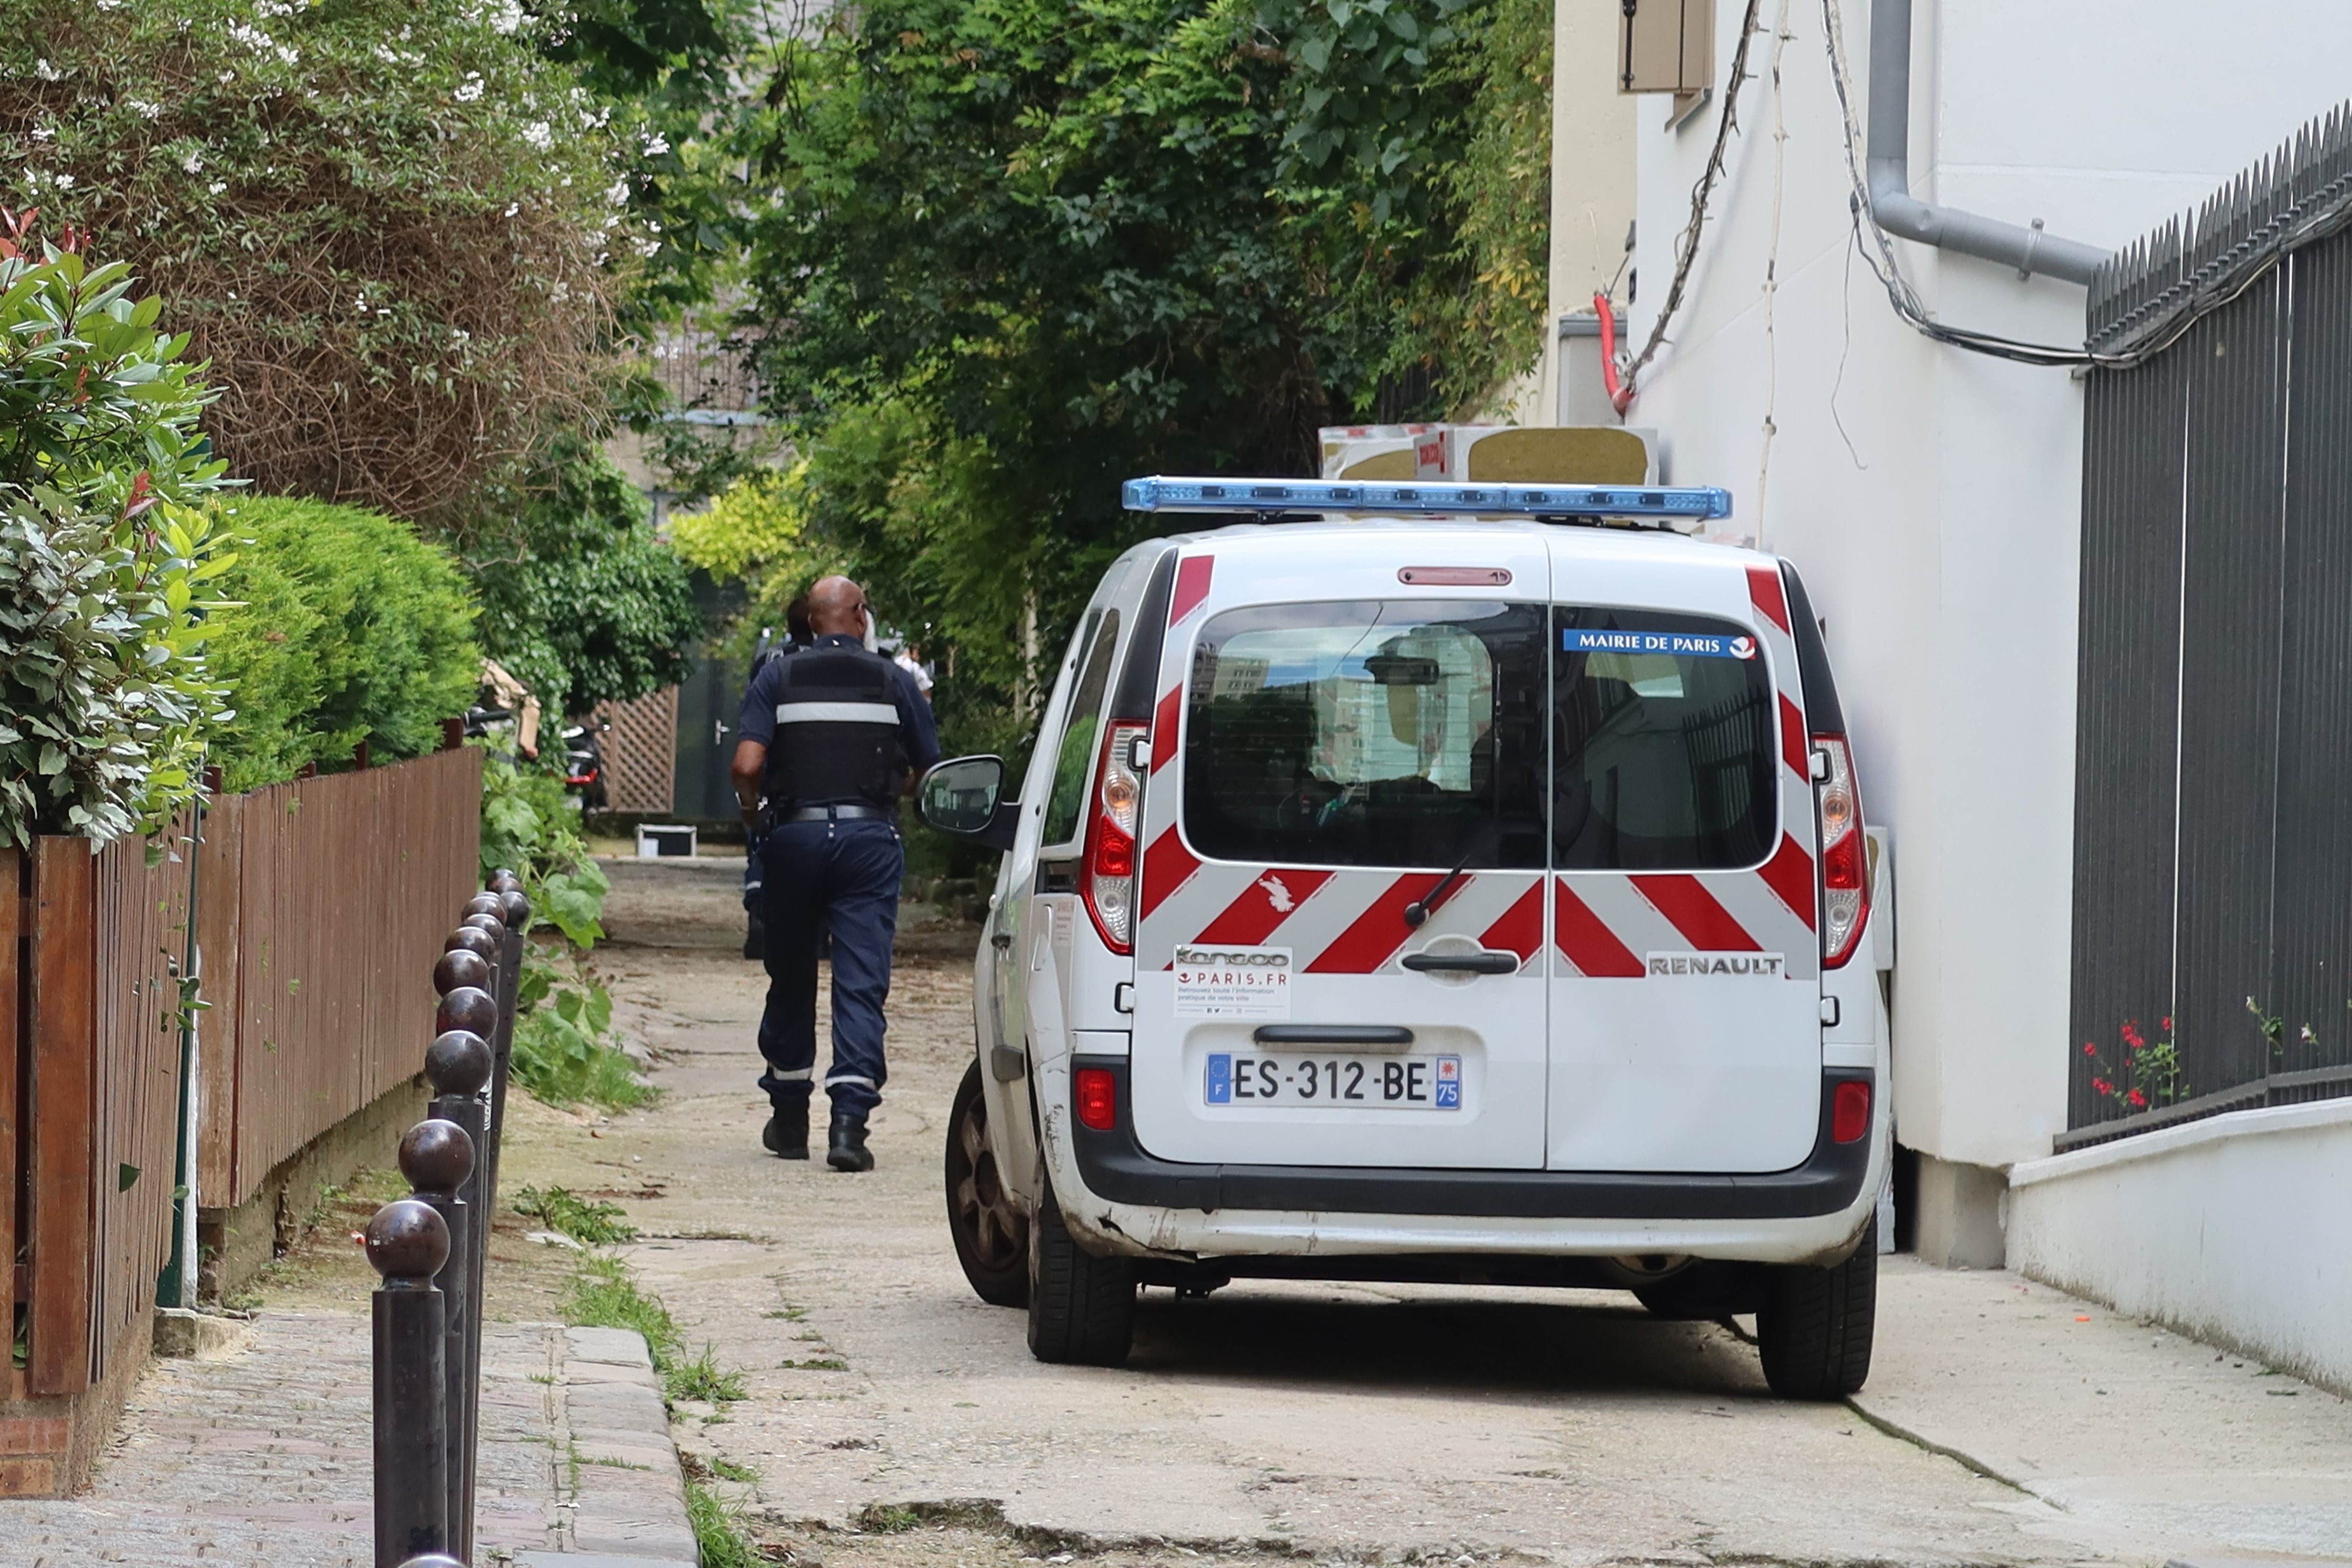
750 0 1541 752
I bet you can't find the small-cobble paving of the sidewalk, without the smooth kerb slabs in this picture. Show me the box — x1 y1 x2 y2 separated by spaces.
0 1314 569 1568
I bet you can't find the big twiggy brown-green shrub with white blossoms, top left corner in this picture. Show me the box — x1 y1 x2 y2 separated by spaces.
0 0 635 517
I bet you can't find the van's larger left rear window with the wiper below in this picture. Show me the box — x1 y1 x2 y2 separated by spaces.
1183 599 1548 868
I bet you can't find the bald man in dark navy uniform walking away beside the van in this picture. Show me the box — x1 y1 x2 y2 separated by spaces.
734 576 938 1171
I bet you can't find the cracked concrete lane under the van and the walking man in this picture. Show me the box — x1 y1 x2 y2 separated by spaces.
510 863 2352 1566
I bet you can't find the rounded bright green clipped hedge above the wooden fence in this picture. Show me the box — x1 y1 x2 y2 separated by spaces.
207 496 482 790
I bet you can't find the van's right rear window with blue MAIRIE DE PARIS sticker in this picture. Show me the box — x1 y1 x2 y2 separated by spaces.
1552 606 1780 872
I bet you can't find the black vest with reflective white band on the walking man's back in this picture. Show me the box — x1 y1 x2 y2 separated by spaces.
767 646 906 811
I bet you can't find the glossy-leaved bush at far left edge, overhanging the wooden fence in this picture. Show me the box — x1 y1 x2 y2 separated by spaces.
0 223 228 844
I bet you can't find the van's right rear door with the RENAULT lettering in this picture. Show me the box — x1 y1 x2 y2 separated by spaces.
1548 552 1820 1173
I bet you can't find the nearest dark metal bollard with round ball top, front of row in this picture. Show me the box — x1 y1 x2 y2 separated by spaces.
367 1199 449 1568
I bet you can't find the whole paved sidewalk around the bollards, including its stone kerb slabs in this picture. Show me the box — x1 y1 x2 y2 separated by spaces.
0 1314 696 1568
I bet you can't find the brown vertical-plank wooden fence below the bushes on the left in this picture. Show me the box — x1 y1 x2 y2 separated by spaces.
0 750 482 1495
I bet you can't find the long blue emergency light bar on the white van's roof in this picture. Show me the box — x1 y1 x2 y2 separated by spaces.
1120 475 1731 522
